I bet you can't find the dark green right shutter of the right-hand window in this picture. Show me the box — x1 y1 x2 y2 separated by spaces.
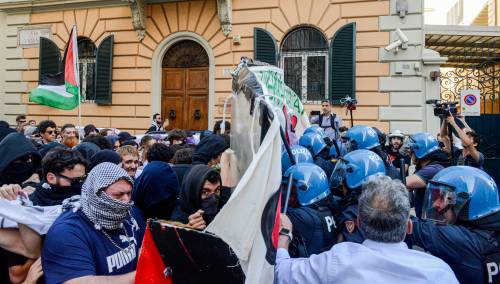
329 23 356 104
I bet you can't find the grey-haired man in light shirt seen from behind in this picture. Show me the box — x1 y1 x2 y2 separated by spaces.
274 177 458 284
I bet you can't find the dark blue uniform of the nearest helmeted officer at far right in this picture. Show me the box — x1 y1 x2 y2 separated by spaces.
408 218 499 283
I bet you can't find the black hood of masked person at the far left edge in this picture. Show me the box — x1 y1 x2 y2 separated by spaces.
0 133 41 186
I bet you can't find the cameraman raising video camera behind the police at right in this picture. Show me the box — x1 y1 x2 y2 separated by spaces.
440 114 484 169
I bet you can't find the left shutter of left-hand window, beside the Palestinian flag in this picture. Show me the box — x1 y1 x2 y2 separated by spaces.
38 37 64 84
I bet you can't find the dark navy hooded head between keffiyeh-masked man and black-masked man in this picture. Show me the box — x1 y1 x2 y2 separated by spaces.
132 161 179 220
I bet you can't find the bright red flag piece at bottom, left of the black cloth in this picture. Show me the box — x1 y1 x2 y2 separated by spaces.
134 224 172 284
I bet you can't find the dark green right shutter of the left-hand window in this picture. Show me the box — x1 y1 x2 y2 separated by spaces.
94 35 114 105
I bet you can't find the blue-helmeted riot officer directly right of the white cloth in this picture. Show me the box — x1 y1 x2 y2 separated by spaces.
282 163 340 257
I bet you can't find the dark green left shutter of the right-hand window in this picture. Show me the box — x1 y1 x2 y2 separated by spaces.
253 28 278 66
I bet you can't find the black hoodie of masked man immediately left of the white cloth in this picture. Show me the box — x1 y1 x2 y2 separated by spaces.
172 165 222 224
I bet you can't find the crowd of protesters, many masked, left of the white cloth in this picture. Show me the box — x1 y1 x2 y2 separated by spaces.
0 116 230 283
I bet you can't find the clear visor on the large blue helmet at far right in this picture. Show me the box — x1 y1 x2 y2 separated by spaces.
422 183 463 225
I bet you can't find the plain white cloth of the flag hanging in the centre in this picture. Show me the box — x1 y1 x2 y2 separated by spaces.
206 114 281 283
